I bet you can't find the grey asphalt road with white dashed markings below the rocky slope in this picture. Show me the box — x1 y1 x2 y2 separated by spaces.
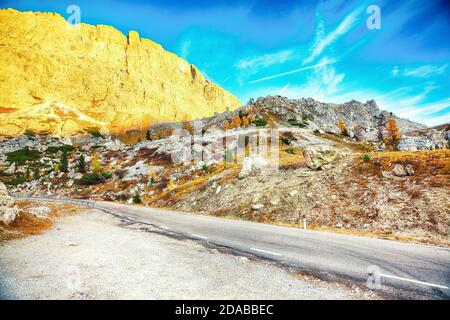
14 196 450 299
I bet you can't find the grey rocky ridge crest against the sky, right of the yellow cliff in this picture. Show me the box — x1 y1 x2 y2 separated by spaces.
194 96 426 141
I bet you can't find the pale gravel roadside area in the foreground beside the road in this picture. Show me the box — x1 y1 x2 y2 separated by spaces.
0 210 372 299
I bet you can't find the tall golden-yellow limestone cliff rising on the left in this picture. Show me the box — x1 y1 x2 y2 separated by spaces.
0 9 241 136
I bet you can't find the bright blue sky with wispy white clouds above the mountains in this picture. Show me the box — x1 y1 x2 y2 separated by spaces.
0 0 450 125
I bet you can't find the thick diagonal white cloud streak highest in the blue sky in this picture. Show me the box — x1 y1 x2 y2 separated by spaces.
303 8 362 64
